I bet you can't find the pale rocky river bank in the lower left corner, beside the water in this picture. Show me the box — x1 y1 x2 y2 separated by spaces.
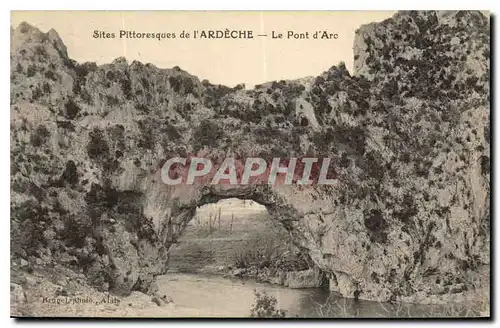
10 265 219 318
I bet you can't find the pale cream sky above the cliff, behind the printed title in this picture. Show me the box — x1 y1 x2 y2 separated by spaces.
11 11 394 88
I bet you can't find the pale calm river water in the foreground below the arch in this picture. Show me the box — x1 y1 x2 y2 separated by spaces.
158 273 446 318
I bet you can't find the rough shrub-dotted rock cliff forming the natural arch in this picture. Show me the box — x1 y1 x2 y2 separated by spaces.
11 12 490 301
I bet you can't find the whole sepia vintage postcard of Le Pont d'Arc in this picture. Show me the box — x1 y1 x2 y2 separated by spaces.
10 11 491 319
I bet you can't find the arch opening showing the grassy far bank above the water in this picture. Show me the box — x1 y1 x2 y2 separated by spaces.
168 198 325 288
